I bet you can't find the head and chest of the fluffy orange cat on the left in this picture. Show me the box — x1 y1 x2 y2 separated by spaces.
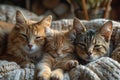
0 11 52 68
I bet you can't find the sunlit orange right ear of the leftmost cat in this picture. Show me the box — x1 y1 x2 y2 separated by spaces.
37 15 52 27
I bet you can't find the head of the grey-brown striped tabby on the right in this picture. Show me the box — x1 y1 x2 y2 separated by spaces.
73 18 113 62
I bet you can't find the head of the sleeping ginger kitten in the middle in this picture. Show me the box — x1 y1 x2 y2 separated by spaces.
44 28 75 58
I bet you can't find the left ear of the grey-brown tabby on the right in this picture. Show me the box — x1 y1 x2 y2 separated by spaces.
73 18 86 33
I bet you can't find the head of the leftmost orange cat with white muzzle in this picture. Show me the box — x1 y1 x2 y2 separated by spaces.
9 10 52 54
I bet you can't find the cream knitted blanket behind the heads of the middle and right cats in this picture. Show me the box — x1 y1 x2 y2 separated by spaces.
51 19 120 62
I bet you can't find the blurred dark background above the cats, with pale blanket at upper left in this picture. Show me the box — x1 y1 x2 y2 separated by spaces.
0 0 120 22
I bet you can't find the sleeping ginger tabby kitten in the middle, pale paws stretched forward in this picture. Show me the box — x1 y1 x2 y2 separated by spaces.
37 28 78 80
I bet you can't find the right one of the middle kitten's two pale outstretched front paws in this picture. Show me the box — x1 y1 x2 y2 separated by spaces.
50 69 64 80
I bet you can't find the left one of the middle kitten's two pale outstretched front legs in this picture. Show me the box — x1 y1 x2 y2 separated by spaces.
36 63 51 80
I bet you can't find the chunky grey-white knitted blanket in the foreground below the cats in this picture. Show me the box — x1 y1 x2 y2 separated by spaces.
0 57 120 80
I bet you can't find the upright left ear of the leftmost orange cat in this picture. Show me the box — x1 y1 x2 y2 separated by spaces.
16 10 26 24
